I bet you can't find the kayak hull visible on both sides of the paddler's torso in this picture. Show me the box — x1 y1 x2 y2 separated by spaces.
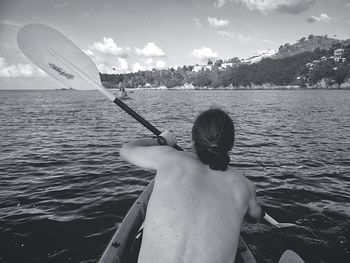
99 181 256 263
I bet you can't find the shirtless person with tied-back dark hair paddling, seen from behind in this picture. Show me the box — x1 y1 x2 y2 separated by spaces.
120 109 261 263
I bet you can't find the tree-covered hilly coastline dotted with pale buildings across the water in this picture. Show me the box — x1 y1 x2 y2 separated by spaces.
100 35 350 89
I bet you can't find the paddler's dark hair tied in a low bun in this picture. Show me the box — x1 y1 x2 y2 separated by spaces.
192 109 235 171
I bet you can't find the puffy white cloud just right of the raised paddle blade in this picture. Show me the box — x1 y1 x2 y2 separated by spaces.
90 37 130 57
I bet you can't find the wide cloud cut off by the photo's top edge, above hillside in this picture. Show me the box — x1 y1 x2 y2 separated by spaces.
238 0 316 14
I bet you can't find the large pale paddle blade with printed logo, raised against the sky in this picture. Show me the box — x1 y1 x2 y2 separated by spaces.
17 24 101 90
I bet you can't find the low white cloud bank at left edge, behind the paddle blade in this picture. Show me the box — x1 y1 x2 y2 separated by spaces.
0 57 47 77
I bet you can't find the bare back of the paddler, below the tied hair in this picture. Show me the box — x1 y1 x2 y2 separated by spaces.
138 151 251 263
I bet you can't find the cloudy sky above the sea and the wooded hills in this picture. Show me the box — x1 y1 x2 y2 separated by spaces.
0 0 350 89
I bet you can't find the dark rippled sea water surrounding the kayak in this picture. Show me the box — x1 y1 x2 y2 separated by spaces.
0 90 350 262
